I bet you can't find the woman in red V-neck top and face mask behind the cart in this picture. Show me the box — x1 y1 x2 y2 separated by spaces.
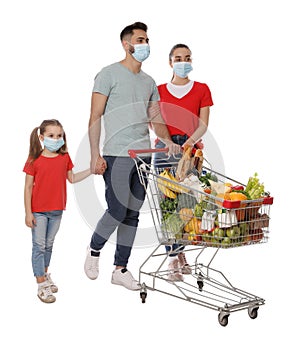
154 44 213 281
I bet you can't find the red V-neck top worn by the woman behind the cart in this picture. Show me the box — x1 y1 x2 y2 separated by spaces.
158 81 213 136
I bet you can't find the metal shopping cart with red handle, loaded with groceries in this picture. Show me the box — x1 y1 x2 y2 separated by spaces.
129 149 273 326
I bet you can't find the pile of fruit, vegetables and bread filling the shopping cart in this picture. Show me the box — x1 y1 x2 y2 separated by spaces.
157 169 273 248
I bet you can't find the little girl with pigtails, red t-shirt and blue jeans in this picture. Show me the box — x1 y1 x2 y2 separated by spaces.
23 120 91 303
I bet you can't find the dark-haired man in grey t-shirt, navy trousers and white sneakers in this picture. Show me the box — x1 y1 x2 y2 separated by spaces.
84 22 180 290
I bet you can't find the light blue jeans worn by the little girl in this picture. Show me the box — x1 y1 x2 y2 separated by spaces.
31 210 63 277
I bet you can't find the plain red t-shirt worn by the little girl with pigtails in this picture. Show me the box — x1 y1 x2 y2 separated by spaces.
23 153 74 213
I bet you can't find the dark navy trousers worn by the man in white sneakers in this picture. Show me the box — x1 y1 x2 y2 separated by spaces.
90 156 151 267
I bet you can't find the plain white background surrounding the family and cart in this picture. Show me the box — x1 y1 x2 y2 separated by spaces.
0 0 300 347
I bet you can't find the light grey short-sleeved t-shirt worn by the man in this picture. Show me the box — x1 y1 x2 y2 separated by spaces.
93 63 159 156
